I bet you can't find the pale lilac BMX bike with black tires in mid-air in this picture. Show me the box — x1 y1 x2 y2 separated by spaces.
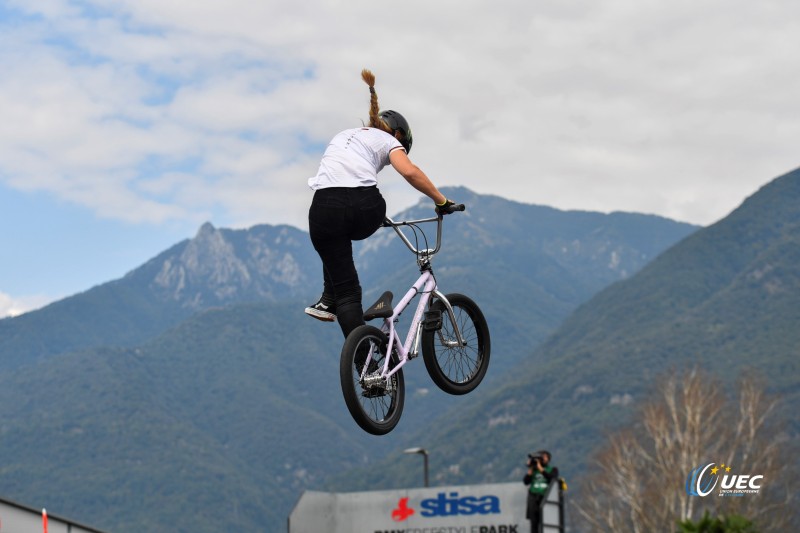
339 205 491 435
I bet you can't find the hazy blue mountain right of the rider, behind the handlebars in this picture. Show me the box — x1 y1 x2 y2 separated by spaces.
355 188 697 379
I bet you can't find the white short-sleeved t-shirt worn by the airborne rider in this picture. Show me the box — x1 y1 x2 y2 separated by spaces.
308 128 404 191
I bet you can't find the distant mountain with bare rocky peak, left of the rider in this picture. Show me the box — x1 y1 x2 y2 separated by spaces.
0 223 319 370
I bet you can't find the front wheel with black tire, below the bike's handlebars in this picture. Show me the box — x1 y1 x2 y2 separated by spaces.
422 294 491 395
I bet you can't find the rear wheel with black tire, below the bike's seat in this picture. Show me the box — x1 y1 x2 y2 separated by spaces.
339 325 405 435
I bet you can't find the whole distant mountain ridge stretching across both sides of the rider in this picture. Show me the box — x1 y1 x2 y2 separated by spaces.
0 188 696 376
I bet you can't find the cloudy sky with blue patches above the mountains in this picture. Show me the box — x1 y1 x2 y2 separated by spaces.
0 0 800 317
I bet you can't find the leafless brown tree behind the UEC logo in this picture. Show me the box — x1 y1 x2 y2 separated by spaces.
577 370 792 533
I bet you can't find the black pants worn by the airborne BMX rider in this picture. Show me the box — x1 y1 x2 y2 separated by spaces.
308 187 386 338
